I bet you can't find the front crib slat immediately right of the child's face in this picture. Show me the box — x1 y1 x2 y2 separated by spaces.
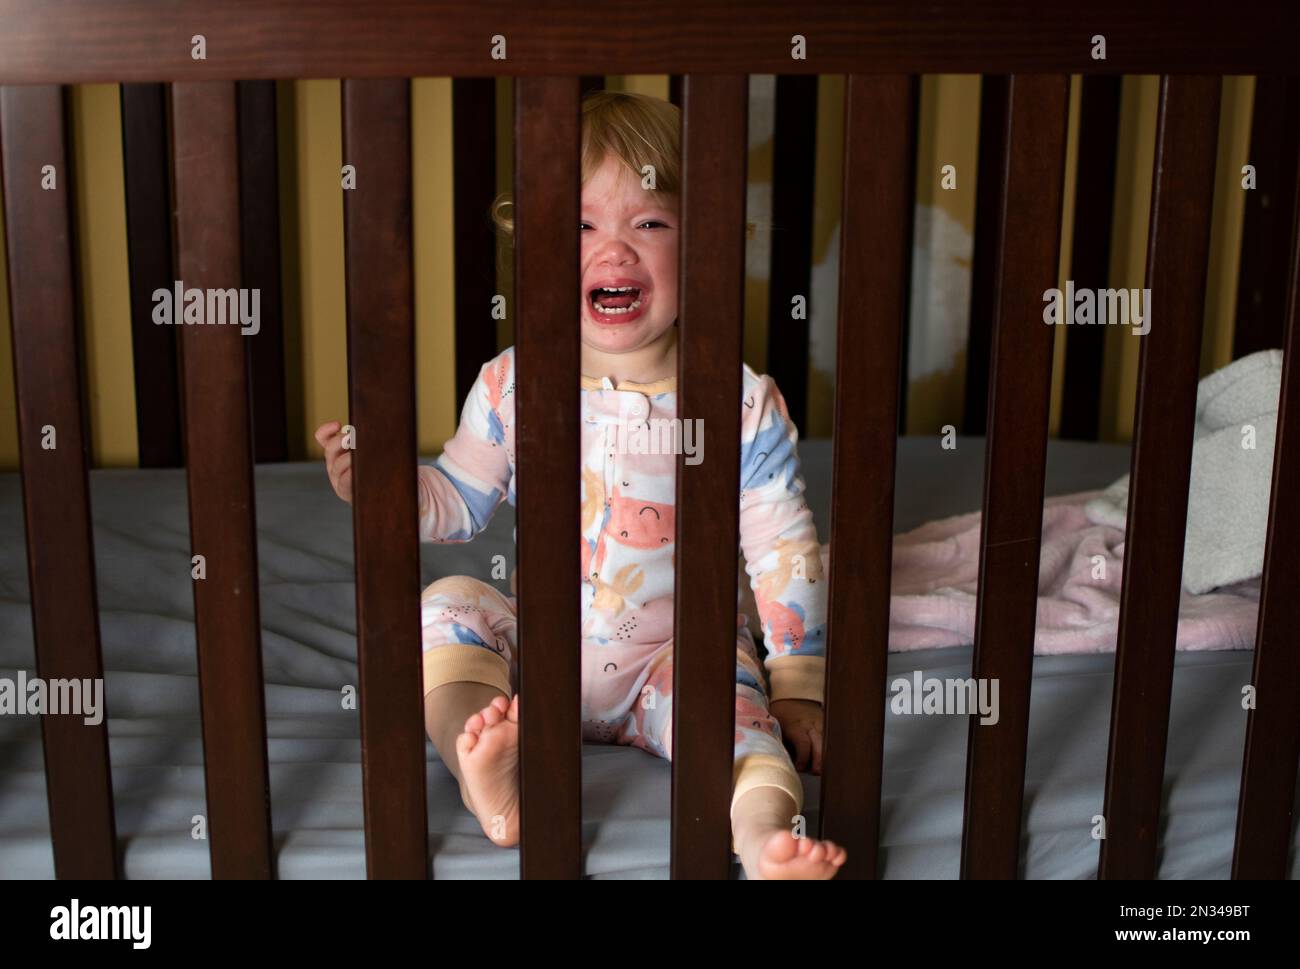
671 74 749 878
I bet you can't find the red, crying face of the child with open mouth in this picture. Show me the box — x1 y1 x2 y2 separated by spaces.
580 157 679 354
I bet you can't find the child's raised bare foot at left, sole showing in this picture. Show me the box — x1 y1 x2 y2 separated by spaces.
456 693 519 848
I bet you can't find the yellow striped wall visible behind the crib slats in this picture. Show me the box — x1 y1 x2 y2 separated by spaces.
0 75 1255 470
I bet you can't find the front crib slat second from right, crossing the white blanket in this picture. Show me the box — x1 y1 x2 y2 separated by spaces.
1099 75 1222 878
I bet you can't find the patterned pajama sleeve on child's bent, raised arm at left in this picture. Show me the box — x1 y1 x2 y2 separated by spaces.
416 351 515 542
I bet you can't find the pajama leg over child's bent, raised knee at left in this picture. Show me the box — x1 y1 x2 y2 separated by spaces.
420 575 519 700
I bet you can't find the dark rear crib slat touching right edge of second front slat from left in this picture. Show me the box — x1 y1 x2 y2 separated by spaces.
238 81 289 462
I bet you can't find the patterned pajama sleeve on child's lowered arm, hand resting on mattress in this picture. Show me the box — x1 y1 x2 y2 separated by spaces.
740 375 828 702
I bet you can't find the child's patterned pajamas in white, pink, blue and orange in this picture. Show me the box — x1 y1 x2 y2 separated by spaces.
419 347 827 848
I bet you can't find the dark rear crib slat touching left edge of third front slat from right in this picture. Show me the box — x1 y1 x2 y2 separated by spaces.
961 74 1011 436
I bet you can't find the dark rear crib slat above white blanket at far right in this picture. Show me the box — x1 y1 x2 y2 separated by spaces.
1232 75 1300 359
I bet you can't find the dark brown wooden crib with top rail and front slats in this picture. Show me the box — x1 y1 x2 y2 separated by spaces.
0 0 1300 878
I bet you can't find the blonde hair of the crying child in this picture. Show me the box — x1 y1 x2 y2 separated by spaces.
490 91 681 246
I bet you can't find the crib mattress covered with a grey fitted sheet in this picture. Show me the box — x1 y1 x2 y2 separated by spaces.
0 437 1279 878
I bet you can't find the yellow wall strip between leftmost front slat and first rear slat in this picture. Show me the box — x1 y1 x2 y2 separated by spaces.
73 85 139 467
